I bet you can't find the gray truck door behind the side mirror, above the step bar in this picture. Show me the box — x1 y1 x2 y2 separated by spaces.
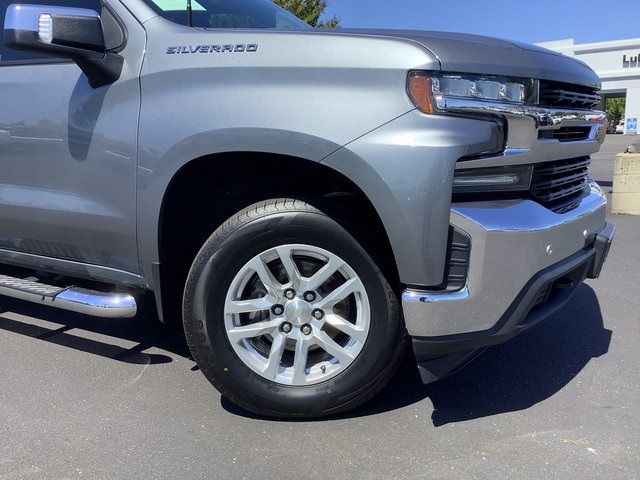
0 0 145 273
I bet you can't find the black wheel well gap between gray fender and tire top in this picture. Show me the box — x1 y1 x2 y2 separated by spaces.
152 151 399 322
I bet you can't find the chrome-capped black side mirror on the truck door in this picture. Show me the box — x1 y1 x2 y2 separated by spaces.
4 4 123 88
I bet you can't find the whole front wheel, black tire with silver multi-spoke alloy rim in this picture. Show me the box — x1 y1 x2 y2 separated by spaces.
184 199 405 417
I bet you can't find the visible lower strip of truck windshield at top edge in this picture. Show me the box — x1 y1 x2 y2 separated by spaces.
144 0 311 29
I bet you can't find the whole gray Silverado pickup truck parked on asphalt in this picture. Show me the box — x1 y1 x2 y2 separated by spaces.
0 0 615 417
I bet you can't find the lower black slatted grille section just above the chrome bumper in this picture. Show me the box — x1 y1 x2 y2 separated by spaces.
530 157 591 213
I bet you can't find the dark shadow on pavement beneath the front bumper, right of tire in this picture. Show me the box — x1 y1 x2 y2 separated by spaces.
338 284 612 427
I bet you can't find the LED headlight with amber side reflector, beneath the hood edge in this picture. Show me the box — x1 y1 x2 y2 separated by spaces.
407 72 538 113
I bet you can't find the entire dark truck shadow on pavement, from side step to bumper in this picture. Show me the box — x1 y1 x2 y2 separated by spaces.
0 285 612 426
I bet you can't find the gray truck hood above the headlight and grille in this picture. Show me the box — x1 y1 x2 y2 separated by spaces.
335 29 600 88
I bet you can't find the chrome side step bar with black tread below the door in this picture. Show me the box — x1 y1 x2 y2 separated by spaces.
0 275 138 318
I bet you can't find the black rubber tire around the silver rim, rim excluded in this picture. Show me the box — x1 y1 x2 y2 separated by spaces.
183 199 407 418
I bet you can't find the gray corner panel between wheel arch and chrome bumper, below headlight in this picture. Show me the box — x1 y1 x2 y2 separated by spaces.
322 111 499 286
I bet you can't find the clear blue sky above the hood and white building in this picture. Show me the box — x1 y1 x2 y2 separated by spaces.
327 0 640 43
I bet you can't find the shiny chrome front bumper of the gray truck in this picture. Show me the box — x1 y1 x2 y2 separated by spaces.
402 182 607 338
